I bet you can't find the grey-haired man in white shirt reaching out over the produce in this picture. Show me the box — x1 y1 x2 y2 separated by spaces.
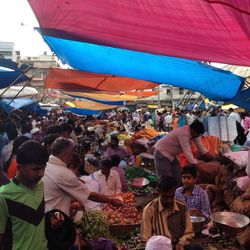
42 137 121 215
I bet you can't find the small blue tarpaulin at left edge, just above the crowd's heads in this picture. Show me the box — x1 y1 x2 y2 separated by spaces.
0 98 48 115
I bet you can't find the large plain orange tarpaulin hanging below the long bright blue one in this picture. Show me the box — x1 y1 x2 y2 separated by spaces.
45 68 158 92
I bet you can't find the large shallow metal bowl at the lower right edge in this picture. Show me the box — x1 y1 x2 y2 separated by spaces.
210 212 250 235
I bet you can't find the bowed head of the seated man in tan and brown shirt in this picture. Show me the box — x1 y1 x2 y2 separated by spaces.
157 176 177 208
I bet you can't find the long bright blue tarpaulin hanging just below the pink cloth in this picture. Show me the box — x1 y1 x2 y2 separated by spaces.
43 33 244 101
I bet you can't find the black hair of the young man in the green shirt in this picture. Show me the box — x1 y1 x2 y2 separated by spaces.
16 140 49 165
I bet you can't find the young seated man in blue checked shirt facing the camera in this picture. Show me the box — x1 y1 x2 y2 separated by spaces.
175 166 211 219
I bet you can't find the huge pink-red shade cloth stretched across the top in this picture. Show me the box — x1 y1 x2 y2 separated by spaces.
28 0 250 65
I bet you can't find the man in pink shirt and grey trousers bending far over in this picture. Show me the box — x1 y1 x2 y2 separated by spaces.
154 120 213 186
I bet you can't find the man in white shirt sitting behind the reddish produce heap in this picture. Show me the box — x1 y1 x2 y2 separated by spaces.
94 159 122 196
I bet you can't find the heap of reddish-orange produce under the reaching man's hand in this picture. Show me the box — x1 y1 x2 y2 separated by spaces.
103 192 142 225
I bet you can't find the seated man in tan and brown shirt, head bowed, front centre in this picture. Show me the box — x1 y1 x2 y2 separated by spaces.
141 176 193 250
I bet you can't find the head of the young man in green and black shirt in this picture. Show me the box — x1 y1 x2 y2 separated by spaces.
16 140 49 188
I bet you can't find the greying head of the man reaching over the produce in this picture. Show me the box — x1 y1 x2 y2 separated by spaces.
51 137 75 166
